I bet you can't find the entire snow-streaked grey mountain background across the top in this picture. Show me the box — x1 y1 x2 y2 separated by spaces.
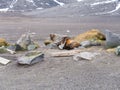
0 0 120 17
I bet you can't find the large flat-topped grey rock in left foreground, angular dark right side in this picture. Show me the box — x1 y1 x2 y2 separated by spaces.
18 52 44 65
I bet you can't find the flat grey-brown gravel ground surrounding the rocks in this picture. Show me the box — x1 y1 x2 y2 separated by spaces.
0 16 120 90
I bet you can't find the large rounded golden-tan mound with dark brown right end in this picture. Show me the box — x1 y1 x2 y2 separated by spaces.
74 29 106 43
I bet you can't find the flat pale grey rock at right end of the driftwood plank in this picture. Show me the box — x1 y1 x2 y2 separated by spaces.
73 52 100 61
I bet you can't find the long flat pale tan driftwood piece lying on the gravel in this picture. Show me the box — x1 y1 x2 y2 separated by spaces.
49 49 83 57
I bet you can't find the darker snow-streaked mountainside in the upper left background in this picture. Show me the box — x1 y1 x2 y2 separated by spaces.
0 0 77 11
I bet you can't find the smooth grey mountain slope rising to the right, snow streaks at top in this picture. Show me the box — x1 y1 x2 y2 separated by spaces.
24 0 120 17
